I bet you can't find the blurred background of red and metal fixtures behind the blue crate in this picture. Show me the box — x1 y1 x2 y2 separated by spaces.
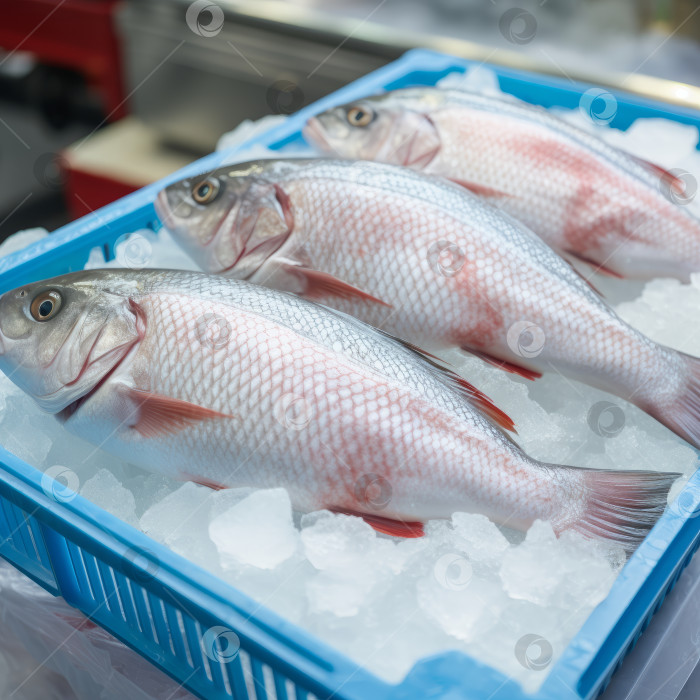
0 0 700 240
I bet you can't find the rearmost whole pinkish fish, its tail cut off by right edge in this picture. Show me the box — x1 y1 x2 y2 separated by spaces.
304 87 700 281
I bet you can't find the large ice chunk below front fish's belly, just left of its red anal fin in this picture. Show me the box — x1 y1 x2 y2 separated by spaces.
209 489 299 569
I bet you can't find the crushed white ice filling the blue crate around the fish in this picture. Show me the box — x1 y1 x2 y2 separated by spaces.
0 68 700 689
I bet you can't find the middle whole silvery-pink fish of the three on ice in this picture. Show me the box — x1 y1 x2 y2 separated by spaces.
156 160 700 446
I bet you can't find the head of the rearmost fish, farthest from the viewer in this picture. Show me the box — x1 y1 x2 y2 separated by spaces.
303 93 440 169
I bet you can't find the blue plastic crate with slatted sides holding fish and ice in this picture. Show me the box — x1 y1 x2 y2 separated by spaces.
0 50 700 700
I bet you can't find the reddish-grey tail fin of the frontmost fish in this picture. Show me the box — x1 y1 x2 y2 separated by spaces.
560 467 682 554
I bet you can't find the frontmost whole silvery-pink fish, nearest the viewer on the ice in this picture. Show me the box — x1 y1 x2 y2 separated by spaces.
0 270 679 551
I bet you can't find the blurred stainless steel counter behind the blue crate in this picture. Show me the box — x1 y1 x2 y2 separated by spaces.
119 0 700 153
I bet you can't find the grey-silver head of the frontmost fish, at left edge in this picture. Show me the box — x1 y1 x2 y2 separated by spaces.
0 270 145 413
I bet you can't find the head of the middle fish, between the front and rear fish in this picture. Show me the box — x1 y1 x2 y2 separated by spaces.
155 161 293 279
